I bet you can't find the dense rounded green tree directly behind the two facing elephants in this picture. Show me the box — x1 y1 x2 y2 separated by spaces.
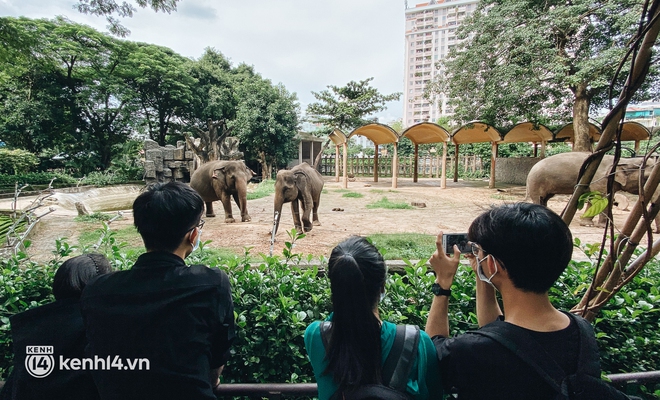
232 75 300 179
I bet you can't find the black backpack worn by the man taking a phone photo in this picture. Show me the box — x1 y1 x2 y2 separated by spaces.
468 313 632 400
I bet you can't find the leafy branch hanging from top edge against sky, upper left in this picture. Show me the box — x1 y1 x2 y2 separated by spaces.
75 0 180 37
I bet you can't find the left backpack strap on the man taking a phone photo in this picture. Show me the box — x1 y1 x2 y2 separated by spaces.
468 321 569 398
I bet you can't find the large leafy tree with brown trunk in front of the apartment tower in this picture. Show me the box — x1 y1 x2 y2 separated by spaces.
427 0 656 151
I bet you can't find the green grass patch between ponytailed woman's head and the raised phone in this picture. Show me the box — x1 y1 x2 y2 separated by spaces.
367 233 435 260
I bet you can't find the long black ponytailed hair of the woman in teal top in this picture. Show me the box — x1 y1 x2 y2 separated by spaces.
325 236 387 393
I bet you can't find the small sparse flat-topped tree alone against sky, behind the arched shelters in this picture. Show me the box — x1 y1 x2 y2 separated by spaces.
307 78 401 133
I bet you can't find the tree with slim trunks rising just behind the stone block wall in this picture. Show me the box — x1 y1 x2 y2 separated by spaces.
126 43 196 146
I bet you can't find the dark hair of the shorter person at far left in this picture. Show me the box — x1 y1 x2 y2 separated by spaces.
53 253 112 300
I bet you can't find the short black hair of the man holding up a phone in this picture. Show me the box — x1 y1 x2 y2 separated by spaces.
468 203 573 293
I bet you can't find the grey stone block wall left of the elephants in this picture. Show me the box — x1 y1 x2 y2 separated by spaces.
144 139 195 184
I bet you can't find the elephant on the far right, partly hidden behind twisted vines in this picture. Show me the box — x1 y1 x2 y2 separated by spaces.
527 152 653 225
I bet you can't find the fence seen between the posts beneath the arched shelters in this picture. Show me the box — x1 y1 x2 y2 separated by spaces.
319 154 487 178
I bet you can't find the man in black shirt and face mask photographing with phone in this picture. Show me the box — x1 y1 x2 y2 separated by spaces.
426 203 600 399
